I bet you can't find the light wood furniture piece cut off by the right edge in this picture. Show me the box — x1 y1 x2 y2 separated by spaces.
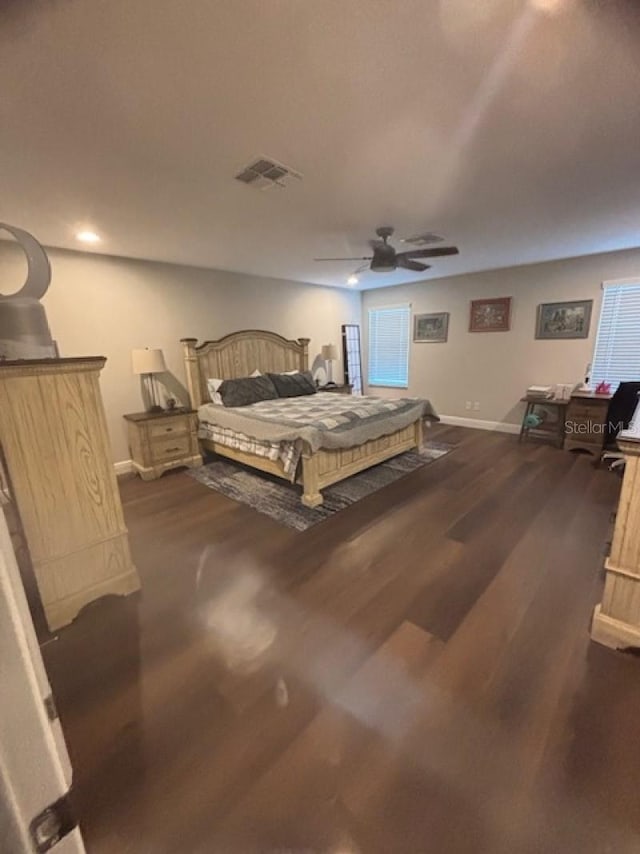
591 431 640 649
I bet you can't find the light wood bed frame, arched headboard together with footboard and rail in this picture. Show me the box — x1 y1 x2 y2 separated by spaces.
182 329 422 507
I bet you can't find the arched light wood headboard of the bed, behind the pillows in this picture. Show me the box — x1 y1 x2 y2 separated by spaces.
181 329 309 409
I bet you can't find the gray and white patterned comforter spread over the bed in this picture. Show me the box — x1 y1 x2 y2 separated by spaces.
198 392 438 458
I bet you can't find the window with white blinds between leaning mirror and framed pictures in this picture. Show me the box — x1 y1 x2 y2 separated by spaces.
369 305 411 388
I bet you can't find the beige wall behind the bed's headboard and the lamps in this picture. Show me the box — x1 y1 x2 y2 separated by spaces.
0 242 360 461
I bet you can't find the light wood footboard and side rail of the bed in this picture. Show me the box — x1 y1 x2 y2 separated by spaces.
200 419 422 507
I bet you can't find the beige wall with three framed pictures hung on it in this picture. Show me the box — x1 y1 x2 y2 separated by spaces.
362 250 640 432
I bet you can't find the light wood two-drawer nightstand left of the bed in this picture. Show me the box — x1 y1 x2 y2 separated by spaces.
124 410 202 480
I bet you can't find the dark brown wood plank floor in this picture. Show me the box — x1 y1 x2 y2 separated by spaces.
45 427 640 854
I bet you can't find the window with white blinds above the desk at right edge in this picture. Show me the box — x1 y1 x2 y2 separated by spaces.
591 281 640 391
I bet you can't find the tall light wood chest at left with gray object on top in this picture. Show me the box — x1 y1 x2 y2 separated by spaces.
0 356 140 629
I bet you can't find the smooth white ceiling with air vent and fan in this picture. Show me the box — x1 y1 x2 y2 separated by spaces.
0 0 640 287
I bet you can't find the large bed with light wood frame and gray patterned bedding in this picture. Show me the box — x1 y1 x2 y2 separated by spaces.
181 329 437 507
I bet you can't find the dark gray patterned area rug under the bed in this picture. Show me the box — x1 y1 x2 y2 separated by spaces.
187 442 453 531
